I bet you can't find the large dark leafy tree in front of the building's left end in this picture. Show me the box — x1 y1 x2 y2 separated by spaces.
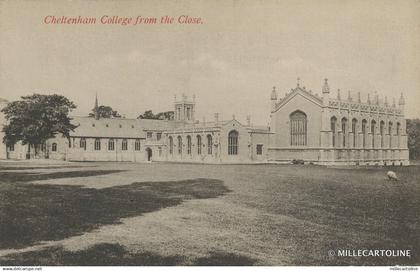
1 94 77 155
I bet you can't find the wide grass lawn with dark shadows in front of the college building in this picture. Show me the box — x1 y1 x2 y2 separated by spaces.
0 162 420 265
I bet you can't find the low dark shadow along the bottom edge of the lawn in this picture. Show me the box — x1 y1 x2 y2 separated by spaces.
0 243 256 266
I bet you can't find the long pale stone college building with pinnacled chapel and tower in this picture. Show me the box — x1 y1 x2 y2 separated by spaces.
0 79 409 165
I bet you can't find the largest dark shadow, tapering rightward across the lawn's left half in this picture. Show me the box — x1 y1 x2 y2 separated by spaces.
0 170 229 249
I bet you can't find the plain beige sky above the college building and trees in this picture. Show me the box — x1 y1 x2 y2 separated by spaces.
0 0 420 124
